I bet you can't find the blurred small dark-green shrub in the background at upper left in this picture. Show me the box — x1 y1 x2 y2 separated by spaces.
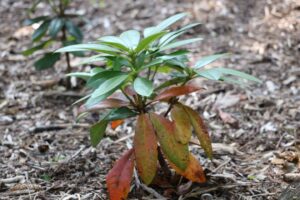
23 0 83 73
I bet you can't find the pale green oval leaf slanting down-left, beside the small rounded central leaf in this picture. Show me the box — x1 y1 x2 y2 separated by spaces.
91 74 128 101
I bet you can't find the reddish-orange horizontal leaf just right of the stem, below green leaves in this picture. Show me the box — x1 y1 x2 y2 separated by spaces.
154 85 203 101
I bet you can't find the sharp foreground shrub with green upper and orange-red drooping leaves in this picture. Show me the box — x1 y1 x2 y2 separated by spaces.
56 13 260 200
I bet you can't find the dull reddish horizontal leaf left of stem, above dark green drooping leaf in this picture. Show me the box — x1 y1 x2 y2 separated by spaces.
79 98 129 113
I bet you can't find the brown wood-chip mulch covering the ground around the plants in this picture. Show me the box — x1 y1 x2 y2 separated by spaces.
0 0 300 199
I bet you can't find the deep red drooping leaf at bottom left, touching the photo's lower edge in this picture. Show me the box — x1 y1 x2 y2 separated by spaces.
106 149 134 200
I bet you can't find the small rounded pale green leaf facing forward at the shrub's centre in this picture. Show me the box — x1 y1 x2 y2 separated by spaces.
133 77 154 97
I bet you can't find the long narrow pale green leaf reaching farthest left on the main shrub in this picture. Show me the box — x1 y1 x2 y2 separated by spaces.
55 43 119 55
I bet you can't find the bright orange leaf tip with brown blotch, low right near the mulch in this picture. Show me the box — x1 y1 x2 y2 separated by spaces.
169 153 206 183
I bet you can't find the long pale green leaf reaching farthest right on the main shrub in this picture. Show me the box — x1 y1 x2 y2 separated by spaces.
197 67 262 83
